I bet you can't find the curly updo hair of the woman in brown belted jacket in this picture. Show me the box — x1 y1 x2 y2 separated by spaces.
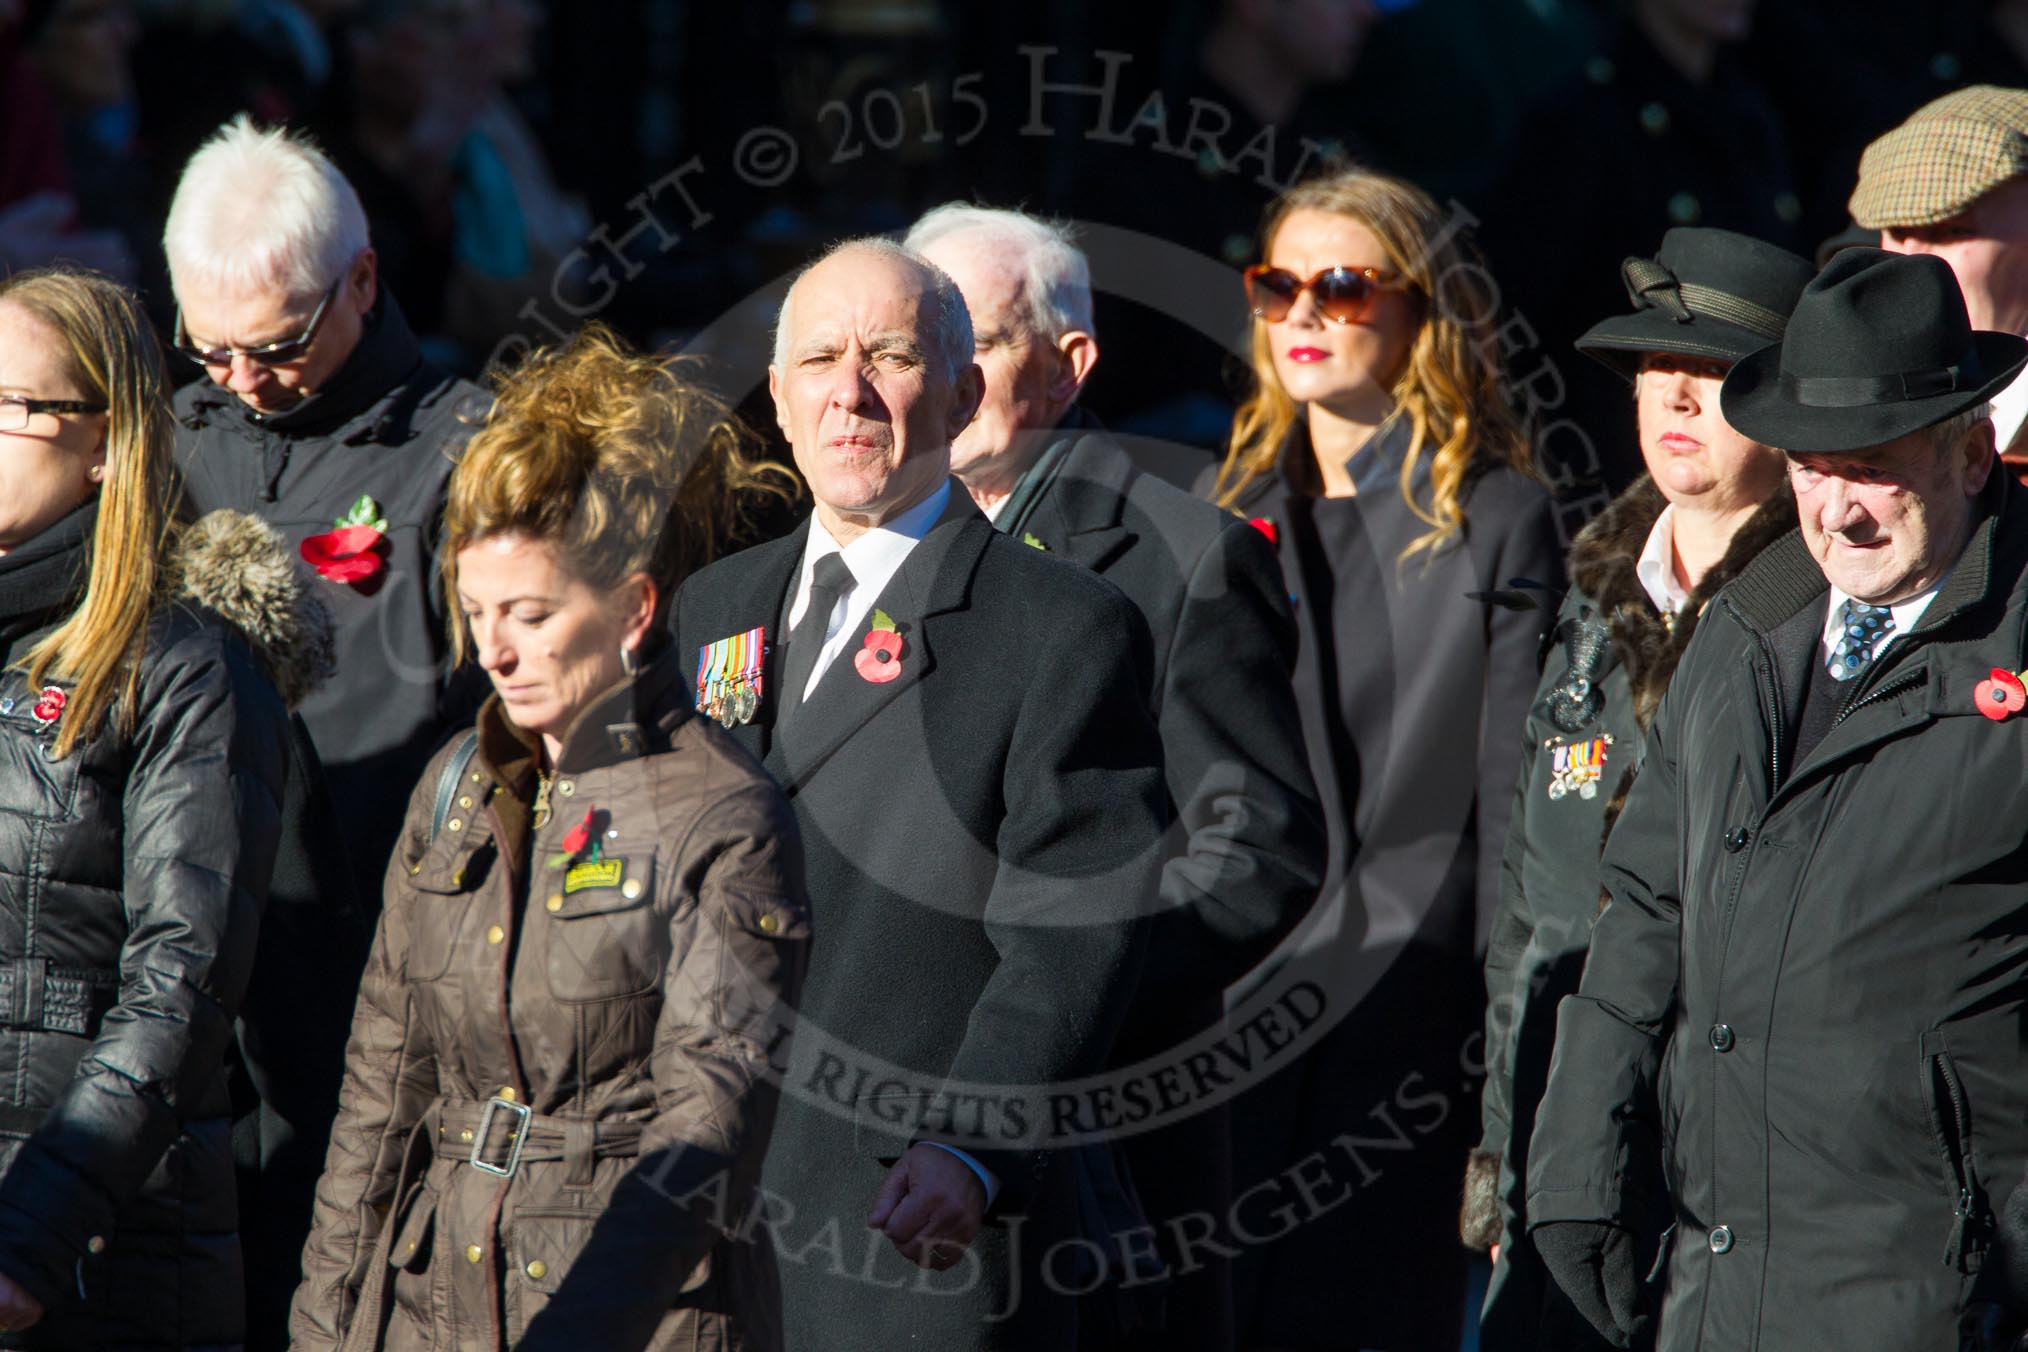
440 324 797 661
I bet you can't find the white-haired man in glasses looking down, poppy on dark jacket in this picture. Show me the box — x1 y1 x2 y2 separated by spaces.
162 118 489 882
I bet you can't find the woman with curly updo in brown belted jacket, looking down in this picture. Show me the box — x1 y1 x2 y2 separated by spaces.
292 330 809 1350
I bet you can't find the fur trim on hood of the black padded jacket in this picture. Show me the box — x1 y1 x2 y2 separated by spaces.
168 509 337 709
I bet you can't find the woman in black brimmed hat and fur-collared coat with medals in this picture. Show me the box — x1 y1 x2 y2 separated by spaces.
1460 229 1811 1352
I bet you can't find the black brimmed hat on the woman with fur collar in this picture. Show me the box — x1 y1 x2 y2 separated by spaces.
1578 225 1815 379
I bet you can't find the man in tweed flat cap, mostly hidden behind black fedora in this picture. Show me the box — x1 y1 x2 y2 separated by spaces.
1850 85 2028 474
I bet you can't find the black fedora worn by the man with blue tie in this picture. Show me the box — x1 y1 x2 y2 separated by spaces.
1720 249 2028 452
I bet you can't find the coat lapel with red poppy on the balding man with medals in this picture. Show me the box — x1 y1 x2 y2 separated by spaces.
754 504 994 795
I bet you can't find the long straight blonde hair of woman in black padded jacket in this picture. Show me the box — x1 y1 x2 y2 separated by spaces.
0 268 178 758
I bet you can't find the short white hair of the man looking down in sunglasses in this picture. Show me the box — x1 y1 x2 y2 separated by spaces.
162 114 371 304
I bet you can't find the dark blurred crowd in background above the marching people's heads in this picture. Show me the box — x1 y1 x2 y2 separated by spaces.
0 0 2028 531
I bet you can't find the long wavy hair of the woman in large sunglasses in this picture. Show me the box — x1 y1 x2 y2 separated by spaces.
1213 168 1535 559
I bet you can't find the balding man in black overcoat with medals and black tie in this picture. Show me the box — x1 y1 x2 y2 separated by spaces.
669 239 1166 1352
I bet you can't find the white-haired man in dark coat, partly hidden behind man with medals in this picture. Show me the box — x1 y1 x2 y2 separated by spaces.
907 203 1324 1348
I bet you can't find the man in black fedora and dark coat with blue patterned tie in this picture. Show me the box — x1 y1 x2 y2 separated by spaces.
1527 249 2028 1352
